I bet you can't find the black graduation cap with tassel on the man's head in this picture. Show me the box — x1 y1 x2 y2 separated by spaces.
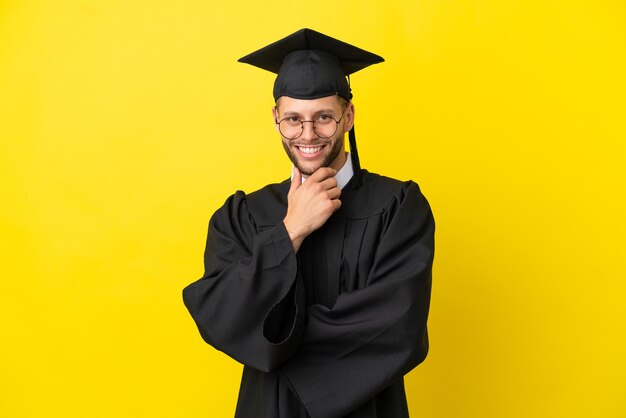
239 28 384 171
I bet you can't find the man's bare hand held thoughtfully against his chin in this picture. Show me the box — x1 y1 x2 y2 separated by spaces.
283 167 341 252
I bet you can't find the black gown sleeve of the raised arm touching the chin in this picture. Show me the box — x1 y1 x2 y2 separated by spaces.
183 192 304 372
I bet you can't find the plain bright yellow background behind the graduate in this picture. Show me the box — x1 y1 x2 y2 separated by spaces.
0 0 626 418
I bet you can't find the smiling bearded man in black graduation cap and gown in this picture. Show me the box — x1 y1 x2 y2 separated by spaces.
183 29 434 418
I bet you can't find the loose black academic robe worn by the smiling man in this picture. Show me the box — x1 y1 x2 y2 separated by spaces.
183 170 435 418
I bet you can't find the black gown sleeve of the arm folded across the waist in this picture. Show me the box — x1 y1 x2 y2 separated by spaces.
278 182 435 418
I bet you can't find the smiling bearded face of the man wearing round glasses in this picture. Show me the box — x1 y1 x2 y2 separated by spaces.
273 96 354 176
